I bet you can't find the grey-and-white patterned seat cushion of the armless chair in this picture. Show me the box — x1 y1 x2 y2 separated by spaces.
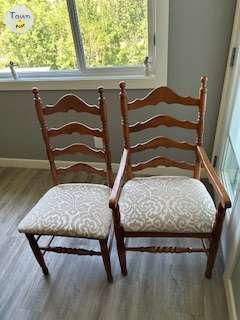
18 183 112 239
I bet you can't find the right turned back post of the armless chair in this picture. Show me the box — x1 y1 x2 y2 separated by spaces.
98 87 114 188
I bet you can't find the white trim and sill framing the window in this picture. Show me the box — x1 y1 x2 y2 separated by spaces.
0 0 169 91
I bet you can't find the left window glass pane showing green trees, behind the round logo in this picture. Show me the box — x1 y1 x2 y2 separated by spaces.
0 0 76 71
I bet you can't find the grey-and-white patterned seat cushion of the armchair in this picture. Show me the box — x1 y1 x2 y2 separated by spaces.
119 176 216 233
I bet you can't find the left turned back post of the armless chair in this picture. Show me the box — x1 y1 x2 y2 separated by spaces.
32 88 58 185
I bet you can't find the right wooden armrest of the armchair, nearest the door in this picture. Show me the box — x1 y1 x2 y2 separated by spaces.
197 146 232 208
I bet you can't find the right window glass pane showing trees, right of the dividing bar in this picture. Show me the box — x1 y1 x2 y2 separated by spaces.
76 0 148 67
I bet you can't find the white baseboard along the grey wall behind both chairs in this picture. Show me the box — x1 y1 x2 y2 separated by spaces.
0 158 192 177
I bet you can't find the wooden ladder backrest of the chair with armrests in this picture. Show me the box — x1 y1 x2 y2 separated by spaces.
120 77 207 179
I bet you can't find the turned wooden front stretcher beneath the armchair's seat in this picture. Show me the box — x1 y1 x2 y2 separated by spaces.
126 246 208 253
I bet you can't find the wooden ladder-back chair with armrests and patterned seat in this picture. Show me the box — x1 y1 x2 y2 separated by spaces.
109 77 231 278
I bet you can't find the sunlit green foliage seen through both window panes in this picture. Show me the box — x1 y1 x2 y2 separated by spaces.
0 0 147 70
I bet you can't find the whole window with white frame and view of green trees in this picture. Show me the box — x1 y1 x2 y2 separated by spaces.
0 0 168 89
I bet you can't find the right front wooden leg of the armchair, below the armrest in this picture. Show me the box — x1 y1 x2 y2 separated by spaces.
205 204 226 279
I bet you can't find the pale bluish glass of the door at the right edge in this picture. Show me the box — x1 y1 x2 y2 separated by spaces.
222 141 240 199
